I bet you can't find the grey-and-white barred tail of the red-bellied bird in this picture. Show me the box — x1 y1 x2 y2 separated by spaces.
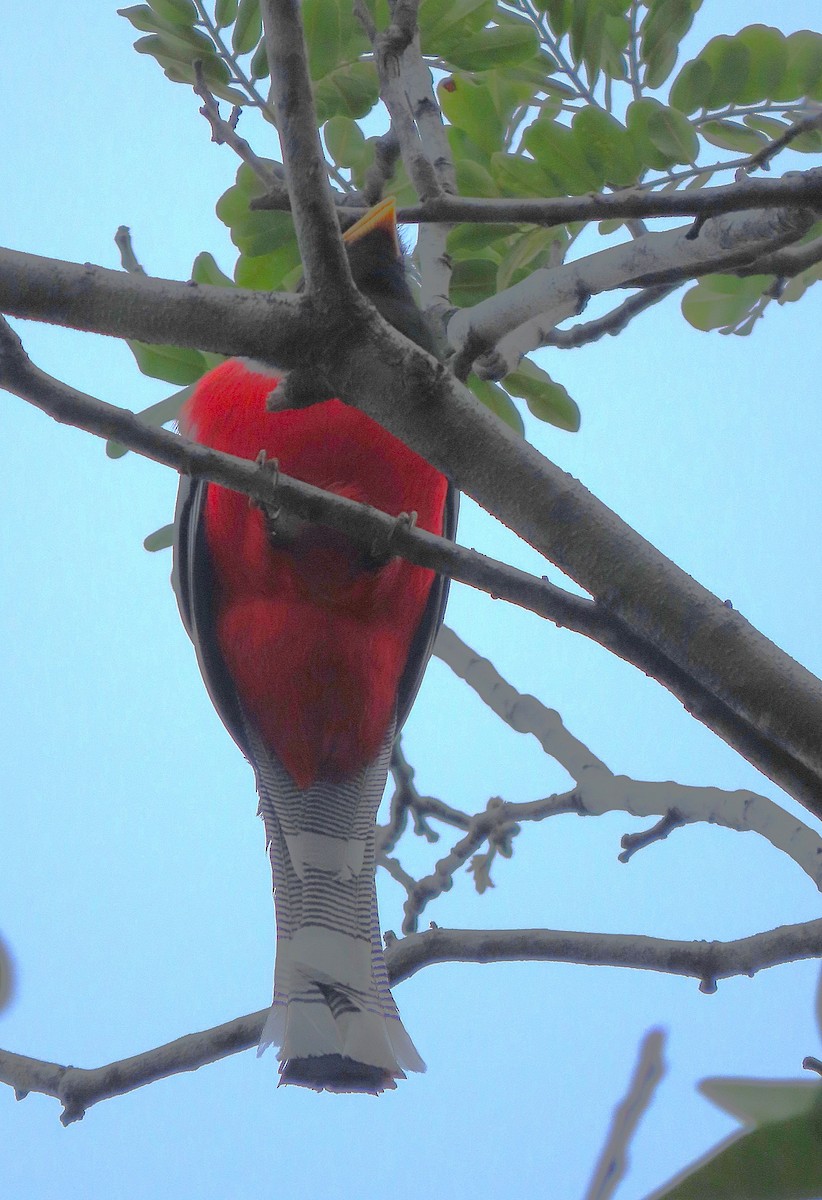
248 728 425 1093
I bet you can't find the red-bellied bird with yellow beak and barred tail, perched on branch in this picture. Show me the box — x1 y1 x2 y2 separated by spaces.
173 197 458 1094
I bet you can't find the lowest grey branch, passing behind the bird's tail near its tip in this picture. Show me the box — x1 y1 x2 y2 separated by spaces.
6 920 822 1124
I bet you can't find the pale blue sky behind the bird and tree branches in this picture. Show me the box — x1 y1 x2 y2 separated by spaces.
0 0 822 1200
